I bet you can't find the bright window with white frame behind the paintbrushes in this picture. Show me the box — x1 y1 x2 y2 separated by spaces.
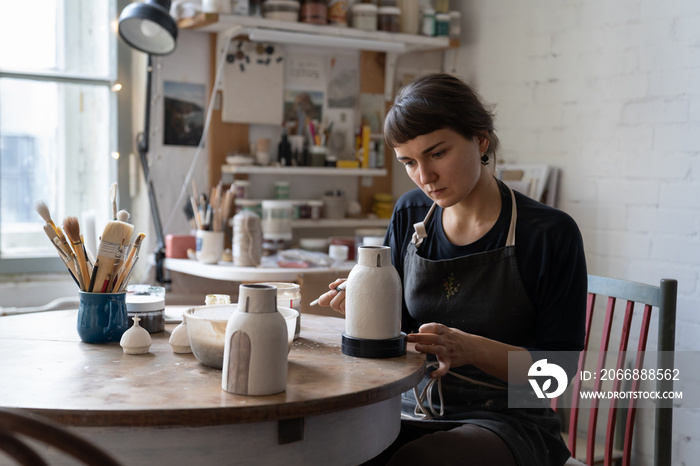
0 0 117 259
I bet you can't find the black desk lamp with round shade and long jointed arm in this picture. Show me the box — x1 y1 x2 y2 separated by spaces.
119 0 177 283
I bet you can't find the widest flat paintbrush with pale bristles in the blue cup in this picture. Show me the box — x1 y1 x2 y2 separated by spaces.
90 210 134 293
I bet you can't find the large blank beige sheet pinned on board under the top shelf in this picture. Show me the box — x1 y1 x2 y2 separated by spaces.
221 42 285 125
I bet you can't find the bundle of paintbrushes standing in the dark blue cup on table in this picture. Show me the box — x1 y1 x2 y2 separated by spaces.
36 202 146 293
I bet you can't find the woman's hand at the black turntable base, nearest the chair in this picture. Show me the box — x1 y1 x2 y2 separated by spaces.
407 323 474 378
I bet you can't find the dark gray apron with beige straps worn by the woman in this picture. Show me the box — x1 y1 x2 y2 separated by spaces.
402 189 569 466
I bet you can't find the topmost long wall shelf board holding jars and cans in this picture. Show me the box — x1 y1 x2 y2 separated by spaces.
178 13 458 52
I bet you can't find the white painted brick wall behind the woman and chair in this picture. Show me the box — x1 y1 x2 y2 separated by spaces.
454 0 700 465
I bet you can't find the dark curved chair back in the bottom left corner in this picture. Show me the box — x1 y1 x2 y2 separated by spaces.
0 408 119 466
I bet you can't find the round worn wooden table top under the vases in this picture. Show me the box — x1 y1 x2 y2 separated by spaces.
0 310 425 427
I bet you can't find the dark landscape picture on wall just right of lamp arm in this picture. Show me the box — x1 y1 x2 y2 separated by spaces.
163 81 206 146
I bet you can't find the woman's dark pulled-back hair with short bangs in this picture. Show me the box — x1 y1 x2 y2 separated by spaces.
384 73 498 155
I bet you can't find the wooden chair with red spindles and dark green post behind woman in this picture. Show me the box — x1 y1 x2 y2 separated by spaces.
552 275 678 466
